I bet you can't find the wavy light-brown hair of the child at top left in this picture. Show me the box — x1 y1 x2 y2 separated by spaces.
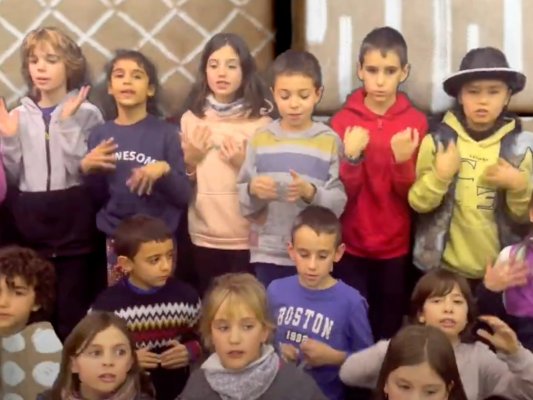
21 26 89 100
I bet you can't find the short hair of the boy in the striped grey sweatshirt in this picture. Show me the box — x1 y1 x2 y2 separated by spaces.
270 49 322 89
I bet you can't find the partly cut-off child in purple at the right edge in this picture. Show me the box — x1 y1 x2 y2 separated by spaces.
478 198 533 351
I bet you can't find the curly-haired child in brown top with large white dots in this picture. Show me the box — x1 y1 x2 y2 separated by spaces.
0 247 63 399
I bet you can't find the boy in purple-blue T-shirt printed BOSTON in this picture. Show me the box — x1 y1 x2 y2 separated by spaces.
267 206 372 400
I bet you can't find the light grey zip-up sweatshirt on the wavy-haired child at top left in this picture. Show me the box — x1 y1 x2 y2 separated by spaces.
1 91 103 192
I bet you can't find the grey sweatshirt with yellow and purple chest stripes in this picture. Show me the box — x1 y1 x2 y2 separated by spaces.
237 120 346 266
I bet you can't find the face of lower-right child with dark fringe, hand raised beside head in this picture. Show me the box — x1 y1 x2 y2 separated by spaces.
418 284 468 343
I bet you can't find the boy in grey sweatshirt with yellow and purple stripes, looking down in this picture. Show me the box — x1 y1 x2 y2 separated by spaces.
238 50 346 286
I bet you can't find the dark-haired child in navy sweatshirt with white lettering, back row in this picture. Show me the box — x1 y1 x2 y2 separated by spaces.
81 50 190 285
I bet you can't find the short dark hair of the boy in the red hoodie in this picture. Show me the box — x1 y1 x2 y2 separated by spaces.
359 26 407 68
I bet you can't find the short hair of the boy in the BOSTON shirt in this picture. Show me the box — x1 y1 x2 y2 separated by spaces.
291 206 342 246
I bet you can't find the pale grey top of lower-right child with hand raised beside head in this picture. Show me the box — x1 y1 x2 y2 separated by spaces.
339 341 533 400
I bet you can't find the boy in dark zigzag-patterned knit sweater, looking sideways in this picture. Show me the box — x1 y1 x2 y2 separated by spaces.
92 215 201 400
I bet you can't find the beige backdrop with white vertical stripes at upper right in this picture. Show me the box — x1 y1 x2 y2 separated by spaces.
293 0 533 114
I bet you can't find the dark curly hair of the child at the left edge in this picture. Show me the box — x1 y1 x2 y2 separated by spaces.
0 246 56 323
